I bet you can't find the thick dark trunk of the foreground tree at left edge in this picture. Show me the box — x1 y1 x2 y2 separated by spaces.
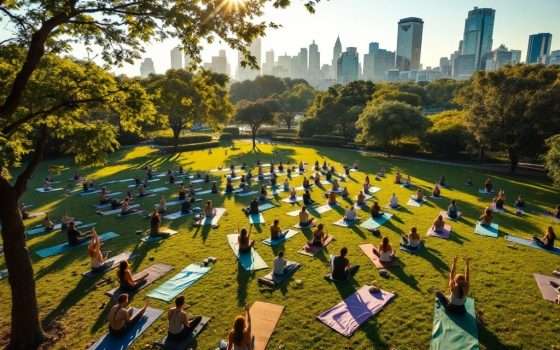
0 178 45 350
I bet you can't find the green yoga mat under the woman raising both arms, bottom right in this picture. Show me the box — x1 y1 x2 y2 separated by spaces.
430 298 480 350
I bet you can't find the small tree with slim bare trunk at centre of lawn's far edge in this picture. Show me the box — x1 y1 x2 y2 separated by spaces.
235 99 280 150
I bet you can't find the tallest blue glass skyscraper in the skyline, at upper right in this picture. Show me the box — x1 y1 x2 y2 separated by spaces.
459 7 496 71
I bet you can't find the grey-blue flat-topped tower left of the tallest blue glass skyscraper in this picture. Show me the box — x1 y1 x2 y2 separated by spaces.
395 17 424 71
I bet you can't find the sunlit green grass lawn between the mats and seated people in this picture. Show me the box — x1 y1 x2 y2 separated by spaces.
0 142 560 349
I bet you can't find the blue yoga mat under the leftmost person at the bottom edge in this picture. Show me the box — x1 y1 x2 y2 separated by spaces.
89 307 163 350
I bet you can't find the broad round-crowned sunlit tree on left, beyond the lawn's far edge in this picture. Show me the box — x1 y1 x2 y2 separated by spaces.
146 69 233 146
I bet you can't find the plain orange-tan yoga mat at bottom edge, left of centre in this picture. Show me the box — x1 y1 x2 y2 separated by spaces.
249 301 284 350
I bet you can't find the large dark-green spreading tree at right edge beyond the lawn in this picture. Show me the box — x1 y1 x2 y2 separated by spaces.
457 65 560 172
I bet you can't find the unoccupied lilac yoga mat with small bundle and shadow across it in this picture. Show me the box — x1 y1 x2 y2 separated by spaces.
317 286 395 337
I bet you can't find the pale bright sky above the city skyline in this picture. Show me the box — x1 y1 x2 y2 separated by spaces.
0 0 560 76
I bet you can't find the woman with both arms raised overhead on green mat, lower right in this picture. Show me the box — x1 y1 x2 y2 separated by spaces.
436 257 470 314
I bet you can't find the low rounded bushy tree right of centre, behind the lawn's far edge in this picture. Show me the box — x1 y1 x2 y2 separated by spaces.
356 101 429 154
